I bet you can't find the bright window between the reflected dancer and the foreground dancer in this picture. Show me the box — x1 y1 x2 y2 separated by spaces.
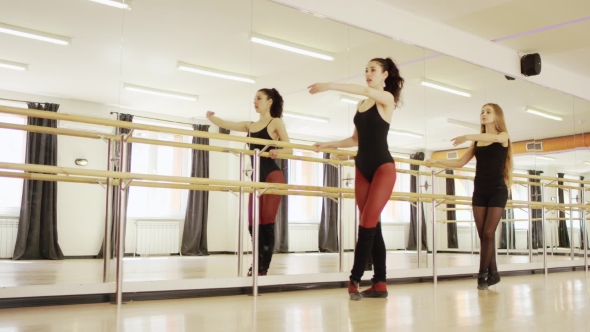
288 151 324 223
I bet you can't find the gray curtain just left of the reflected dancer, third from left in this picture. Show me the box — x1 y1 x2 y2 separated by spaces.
185 125 209 256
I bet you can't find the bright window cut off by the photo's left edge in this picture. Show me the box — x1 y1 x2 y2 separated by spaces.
0 114 27 216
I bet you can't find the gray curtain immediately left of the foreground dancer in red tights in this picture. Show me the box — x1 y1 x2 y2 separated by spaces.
318 153 340 252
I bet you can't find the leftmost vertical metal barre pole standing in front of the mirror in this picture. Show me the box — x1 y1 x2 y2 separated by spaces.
116 135 126 305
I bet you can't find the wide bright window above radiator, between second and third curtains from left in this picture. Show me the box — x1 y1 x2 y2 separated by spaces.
128 123 192 218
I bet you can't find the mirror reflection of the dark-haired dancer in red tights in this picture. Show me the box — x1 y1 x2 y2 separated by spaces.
207 89 293 276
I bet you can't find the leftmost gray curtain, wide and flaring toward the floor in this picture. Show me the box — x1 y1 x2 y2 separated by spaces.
12 103 64 260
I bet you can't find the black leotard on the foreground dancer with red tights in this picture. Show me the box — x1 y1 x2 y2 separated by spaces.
354 104 394 182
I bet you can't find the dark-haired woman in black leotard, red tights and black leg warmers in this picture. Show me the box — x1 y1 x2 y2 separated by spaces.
309 58 404 300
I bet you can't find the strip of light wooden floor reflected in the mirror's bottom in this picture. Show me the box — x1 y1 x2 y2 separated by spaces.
0 251 582 286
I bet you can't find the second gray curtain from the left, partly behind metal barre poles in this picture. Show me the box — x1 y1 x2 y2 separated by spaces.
96 113 133 258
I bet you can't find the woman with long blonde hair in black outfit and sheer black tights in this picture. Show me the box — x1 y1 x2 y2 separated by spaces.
426 104 512 290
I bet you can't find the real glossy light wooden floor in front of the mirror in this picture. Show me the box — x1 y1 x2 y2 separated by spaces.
0 272 590 332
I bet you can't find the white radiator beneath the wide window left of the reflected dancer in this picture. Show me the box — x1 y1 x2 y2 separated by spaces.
135 221 180 255
